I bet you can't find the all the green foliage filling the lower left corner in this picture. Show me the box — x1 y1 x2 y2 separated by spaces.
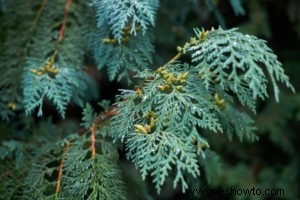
0 113 126 200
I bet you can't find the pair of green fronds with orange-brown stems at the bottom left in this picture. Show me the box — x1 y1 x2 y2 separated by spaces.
17 129 125 200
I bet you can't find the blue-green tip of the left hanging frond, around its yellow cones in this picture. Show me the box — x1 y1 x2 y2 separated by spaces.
23 59 86 117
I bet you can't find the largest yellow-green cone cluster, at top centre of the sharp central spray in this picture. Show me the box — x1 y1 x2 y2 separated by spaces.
157 67 189 91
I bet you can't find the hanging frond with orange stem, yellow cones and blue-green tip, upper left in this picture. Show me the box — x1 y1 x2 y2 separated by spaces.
23 1 92 117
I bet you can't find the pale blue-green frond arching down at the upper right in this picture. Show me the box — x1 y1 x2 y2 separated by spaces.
183 28 293 111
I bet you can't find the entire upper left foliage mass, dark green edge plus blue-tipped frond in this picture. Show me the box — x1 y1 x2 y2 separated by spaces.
0 0 93 119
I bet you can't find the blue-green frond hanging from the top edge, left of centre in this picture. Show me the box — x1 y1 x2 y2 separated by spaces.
91 0 158 82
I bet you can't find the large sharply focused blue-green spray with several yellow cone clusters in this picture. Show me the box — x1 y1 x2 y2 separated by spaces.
113 28 293 192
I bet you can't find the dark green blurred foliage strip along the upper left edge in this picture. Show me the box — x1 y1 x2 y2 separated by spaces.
0 1 37 120
